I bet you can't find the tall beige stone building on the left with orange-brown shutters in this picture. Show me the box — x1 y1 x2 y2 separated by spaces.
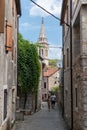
0 0 21 130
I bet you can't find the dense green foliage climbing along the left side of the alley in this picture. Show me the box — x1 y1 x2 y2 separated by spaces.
18 34 40 94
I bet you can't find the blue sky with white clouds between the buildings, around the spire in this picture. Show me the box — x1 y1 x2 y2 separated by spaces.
19 0 62 59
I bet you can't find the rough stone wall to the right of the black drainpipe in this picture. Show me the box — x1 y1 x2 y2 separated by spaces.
72 2 87 130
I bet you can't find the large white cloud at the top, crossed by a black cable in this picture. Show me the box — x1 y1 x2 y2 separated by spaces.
30 0 62 17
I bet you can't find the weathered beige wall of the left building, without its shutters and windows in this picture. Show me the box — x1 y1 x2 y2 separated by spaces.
0 0 17 130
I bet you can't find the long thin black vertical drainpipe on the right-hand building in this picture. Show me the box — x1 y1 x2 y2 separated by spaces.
70 0 73 130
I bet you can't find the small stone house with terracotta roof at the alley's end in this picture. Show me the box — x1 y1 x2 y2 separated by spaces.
42 68 59 101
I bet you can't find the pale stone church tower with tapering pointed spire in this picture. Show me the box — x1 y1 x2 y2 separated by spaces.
37 18 49 66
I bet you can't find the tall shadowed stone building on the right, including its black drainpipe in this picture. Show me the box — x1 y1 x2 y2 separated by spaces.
61 0 87 130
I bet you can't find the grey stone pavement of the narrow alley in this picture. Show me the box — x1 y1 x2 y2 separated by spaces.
15 102 67 130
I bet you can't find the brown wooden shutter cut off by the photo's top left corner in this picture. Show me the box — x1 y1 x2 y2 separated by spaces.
0 0 5 33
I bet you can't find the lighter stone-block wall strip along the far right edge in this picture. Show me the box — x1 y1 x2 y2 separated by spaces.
80 4 87 130
